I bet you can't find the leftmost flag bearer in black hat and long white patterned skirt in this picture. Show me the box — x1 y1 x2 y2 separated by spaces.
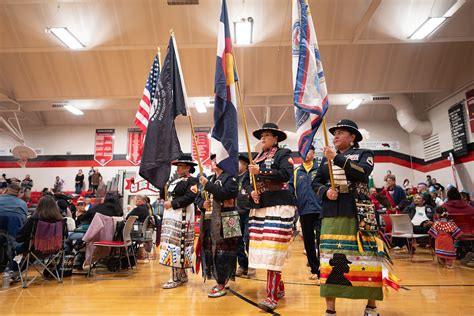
160 155 198 289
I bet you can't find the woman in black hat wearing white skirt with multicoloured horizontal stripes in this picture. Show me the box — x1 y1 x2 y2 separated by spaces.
249 123 295 311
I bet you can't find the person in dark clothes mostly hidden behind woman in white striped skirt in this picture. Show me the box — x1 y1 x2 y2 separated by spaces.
235 153 257 278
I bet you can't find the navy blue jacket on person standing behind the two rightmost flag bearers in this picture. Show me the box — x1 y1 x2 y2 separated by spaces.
288 160 321 216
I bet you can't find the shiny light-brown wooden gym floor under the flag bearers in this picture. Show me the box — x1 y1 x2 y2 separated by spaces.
0 240 474 316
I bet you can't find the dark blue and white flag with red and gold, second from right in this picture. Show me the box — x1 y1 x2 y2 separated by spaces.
211 0 239 176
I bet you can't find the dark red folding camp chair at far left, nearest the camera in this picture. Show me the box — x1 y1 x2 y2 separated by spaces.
16 220 67 288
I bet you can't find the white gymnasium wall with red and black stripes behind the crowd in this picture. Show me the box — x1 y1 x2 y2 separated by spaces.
0 100 473 190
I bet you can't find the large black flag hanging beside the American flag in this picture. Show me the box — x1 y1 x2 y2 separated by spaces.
139 38 187 189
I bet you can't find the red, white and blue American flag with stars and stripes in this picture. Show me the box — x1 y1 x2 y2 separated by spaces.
134 54 160 134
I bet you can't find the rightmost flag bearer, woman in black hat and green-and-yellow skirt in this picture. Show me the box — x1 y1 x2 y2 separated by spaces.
312 119 383 315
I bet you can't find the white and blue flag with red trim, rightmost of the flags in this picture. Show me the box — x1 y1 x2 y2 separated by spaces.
292 0 329 159
